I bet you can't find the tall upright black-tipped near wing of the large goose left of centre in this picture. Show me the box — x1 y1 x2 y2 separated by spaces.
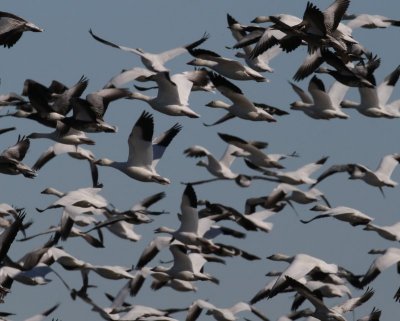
127 111 154 167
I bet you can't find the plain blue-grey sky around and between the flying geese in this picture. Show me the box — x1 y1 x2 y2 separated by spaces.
0 0 400 321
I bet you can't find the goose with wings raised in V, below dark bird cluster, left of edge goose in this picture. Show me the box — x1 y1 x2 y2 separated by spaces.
290 76 349 119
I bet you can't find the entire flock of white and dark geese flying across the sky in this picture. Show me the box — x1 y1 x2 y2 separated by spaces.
0 0 400 321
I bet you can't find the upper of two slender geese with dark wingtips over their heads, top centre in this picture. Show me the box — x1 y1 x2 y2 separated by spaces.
187 49 269 82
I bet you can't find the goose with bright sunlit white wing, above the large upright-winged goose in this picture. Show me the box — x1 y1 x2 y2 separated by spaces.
129 71 200 118
